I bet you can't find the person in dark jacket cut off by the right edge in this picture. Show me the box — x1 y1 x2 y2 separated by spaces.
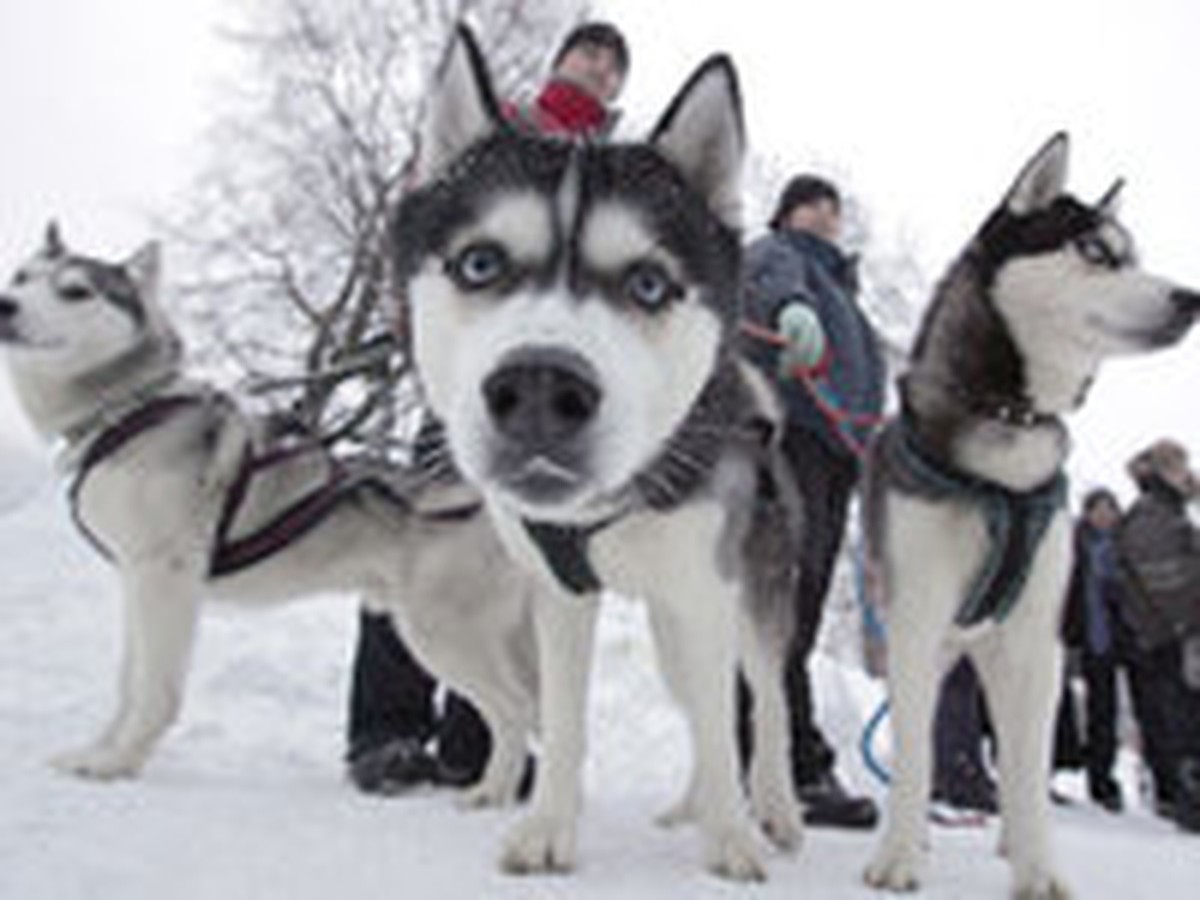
1116 440 1200 833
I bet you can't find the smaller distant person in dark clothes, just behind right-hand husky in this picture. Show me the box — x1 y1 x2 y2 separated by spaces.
1063 487 1132 812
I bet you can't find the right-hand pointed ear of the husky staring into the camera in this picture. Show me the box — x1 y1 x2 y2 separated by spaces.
650 54 745 228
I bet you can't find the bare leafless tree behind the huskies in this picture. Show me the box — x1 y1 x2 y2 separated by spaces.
172 0 586 450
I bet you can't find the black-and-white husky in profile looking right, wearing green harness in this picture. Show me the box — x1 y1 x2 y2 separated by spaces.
866 134 1200 898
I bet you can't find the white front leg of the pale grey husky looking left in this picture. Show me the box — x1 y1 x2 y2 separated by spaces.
53 564 199 779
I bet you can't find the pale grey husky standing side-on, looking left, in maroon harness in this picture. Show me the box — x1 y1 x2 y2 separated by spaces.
0 227 536 804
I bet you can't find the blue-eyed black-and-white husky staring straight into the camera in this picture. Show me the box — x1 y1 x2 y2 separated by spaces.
394 31 800 878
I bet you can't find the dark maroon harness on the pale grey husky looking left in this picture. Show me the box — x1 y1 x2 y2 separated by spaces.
70 392 482 577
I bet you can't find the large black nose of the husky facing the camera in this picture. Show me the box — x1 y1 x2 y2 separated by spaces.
484 348 601 446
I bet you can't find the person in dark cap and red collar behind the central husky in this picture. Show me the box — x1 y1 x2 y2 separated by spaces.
347 22 630 794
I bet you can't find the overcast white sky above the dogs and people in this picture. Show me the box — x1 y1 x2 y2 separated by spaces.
0 0 1200 493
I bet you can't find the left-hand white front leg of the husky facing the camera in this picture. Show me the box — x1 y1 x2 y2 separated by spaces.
500 592 598 875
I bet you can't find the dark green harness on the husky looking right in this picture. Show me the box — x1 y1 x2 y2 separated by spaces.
880 415 1067 628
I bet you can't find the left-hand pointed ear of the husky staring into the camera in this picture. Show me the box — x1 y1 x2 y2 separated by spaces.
419 25 500 181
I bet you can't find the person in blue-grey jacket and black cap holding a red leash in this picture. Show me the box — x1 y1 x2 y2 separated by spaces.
742 174 886 828
